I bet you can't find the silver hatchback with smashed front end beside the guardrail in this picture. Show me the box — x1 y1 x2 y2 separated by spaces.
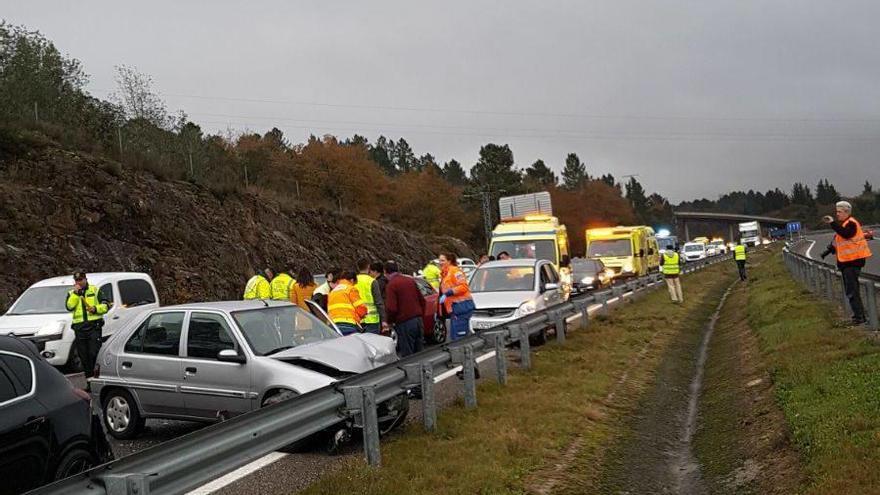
90 300 408 438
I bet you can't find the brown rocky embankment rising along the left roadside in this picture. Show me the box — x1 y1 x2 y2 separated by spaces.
0 148 473 311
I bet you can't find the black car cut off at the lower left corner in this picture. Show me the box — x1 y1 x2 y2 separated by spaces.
0 336 112 494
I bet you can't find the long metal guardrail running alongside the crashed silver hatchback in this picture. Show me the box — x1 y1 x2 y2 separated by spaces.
30 255 731 495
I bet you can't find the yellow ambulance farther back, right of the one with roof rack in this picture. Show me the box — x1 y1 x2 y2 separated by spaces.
585 225 660 278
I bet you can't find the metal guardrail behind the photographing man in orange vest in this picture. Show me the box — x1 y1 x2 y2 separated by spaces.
782 245 880 330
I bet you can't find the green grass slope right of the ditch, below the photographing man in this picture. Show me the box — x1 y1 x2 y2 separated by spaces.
746 257 880 494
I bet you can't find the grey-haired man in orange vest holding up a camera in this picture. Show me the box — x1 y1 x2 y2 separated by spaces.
822 201 871 326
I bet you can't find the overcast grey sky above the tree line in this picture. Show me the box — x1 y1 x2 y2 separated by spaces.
0 0 880 201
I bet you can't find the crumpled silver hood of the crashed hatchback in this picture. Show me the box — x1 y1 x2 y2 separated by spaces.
270 333 398 373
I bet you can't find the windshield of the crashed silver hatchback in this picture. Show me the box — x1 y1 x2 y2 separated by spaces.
232 306 340 356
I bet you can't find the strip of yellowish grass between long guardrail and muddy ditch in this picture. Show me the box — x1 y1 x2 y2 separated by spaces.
304 263 734 495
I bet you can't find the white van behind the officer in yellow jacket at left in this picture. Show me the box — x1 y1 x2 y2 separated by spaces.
0 272 159 368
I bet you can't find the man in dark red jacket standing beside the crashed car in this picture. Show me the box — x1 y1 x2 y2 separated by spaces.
384 261 425 357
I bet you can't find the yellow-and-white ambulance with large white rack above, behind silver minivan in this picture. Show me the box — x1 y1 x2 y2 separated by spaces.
489 191 569 268
